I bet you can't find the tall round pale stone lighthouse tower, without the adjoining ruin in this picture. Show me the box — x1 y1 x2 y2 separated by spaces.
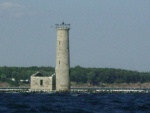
55 22 70 91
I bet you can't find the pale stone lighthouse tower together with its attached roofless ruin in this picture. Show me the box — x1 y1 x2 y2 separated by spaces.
30 22 70 91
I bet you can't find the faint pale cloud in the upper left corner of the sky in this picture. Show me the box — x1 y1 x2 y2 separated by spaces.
0 2 24 17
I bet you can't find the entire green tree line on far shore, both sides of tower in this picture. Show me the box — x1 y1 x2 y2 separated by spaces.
0 66 150 85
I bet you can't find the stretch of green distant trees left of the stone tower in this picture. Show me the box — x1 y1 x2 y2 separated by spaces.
0 66 54 86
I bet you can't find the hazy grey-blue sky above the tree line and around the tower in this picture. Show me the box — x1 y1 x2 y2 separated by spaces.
0 0 150 72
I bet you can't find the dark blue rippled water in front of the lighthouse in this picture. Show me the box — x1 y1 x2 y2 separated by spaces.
0 93 150 113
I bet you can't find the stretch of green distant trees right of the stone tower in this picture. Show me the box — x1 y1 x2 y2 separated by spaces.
71 66 150 85
